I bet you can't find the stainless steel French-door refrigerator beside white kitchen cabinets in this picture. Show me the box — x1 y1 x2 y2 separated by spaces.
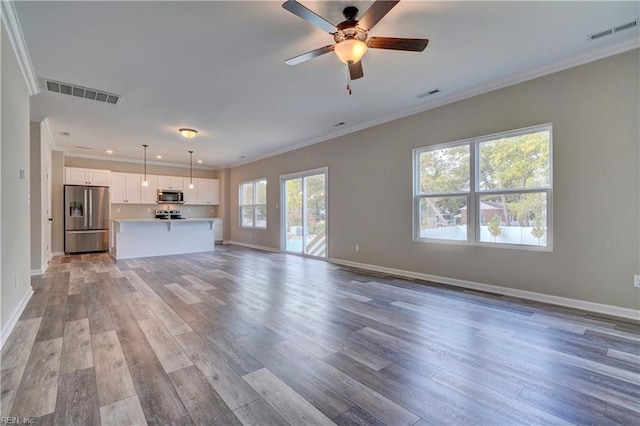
64 185 109 253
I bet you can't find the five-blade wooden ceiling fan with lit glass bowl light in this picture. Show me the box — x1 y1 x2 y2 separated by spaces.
282 0 429 94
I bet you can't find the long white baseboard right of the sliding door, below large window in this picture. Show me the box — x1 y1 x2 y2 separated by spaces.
328 259 640 321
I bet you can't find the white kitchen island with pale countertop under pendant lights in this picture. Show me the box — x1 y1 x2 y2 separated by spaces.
111 218 215 259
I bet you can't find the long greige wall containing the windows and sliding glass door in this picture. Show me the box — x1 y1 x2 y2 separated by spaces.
226 50 640 309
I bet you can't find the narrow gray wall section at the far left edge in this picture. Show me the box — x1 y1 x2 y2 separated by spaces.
0 23 31 341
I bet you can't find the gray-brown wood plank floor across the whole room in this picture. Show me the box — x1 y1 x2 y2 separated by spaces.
1 246 640 425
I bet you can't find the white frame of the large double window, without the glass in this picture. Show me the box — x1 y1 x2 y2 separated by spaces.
412 123 553 252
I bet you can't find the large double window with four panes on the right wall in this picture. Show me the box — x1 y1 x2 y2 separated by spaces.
414 125 552 249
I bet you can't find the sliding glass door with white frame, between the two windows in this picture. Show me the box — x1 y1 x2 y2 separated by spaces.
280 168 328 257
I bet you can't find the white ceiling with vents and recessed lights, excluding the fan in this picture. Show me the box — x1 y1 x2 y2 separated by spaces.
14 0 640 168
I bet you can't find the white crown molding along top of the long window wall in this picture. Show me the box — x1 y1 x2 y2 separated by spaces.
225 35 640 168
